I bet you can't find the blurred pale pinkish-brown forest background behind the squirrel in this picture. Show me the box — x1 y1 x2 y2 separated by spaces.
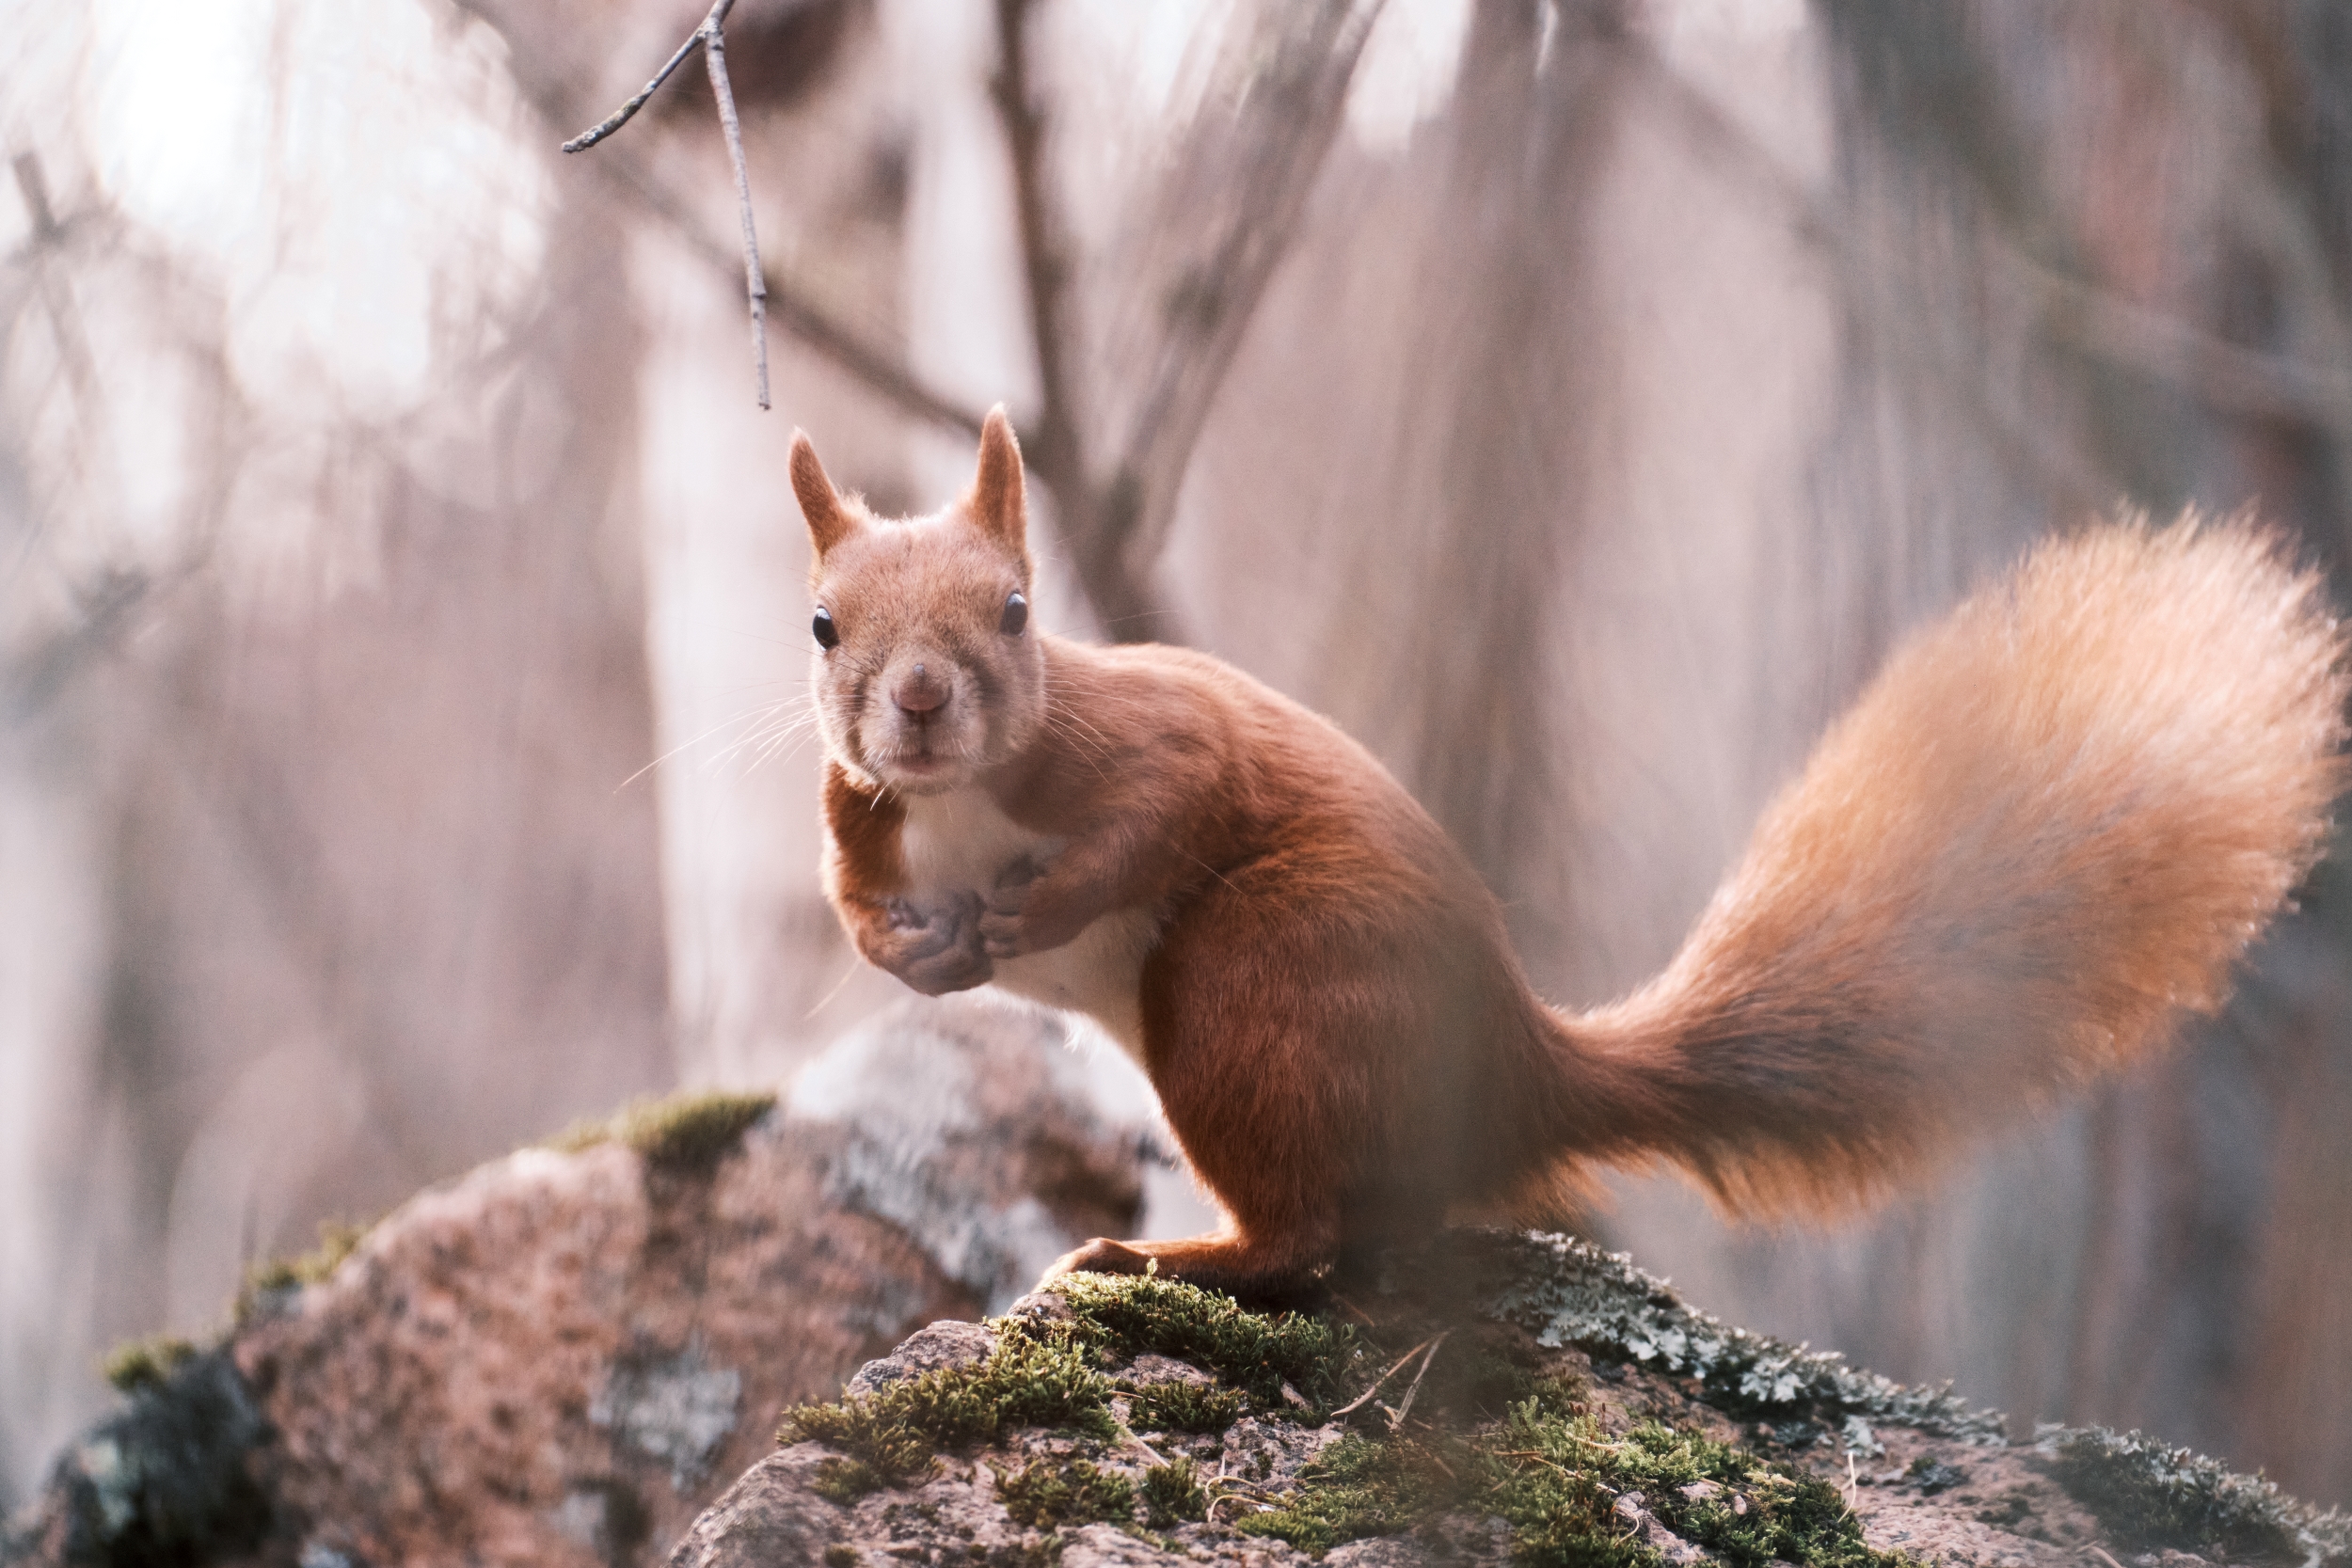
0 0 2352 1505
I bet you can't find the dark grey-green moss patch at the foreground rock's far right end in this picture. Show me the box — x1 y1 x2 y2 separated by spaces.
2049 1427 2305 1561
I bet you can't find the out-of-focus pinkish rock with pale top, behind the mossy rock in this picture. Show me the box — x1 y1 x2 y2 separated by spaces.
0 1004 1141 1568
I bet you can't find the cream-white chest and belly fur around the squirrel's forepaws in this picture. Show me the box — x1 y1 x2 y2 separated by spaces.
898 790 1160 1063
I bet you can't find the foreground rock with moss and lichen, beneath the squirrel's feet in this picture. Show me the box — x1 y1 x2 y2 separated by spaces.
671 1232 2352 1568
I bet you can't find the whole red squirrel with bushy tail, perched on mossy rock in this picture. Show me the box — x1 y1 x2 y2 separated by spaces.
790 406 2345 1295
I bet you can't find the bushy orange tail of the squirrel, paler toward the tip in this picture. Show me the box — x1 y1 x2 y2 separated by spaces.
1560 517 2345 1213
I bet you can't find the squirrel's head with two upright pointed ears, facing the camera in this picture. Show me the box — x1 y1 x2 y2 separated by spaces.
793 404 1044 795
